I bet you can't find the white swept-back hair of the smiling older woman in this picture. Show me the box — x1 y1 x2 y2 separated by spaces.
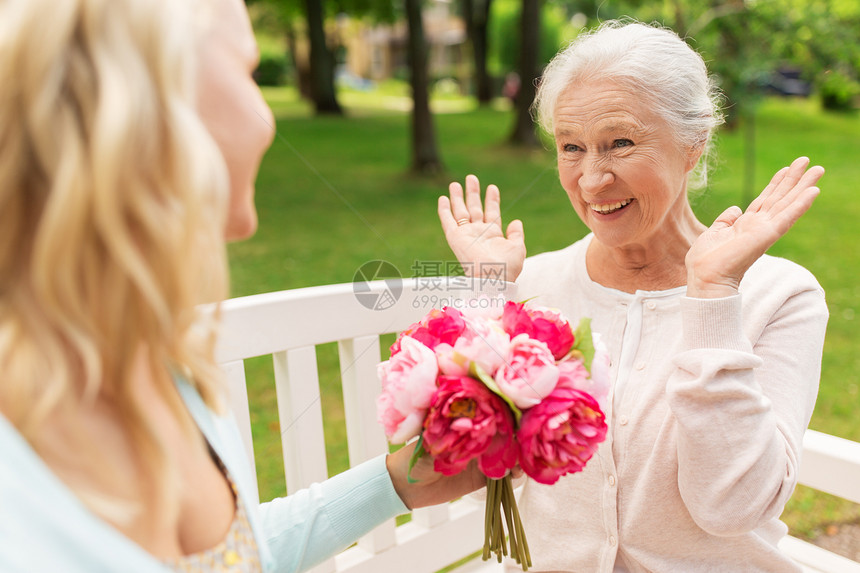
533 20 723 188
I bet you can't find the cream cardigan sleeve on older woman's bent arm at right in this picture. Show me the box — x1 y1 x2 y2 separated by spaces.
667 284 828 536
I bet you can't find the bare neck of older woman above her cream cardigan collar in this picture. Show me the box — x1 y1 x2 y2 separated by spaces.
586 218 706 293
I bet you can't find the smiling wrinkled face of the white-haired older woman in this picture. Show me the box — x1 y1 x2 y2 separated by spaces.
553 81 701 247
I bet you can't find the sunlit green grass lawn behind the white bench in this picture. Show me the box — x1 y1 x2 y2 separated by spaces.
225 86 860 536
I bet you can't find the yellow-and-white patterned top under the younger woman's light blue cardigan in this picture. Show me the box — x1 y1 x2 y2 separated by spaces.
164 452 263 573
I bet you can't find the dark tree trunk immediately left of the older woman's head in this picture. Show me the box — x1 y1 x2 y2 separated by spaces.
510 0 541 147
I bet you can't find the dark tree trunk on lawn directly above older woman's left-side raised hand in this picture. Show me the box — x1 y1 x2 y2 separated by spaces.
406 0 443 174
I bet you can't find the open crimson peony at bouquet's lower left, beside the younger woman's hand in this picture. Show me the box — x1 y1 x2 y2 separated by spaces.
424 376 517 479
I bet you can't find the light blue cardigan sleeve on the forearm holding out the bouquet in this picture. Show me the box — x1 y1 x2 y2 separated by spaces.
255 455 409 572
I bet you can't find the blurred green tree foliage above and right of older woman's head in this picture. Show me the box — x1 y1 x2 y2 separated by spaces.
600 0 860 114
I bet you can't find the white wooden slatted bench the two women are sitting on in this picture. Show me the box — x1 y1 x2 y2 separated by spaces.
217 277 860 573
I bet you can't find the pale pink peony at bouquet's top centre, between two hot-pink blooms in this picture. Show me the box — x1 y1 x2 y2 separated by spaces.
436 318 511 376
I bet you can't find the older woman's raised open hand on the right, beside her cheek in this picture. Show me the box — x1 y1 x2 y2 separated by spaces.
686 157 824 298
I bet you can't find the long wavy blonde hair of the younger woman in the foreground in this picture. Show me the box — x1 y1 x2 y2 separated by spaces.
0 0 228 512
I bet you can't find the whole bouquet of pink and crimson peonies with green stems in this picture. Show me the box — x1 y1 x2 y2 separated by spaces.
377 300 609 571
